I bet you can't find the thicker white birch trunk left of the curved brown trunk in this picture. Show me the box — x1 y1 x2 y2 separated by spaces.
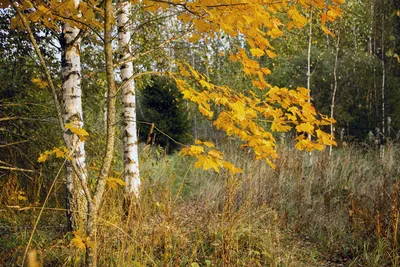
61 0 87 230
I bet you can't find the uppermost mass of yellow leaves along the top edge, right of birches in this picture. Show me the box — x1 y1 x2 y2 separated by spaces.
142 0 344 89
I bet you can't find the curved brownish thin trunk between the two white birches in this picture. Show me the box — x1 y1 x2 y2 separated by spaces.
86 0 117 267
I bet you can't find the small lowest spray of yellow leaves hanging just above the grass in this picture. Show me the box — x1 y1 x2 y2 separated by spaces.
180 140 242 174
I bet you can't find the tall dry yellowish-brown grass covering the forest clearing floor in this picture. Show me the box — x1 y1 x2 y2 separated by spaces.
0 142 400 266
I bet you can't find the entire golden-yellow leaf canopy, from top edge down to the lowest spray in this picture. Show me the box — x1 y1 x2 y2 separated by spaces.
14 0 344 173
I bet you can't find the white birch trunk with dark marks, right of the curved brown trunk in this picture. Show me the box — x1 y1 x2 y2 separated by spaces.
117 0 140 197
